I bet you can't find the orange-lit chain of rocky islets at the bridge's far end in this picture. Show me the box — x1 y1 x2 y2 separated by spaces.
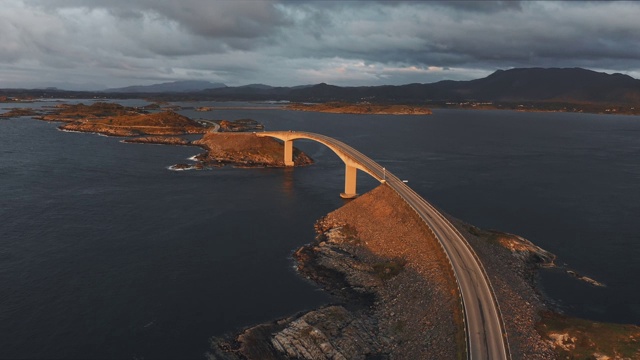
31 102 313 170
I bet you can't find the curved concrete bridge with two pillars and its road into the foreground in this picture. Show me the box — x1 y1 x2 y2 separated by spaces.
256 131 511 360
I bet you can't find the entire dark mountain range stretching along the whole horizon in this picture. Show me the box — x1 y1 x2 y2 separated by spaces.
0 68 640 108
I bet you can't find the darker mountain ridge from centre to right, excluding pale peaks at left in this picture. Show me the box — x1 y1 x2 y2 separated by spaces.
175 68 640 104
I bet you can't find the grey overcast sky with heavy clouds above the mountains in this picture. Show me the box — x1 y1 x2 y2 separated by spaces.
0 0 640 89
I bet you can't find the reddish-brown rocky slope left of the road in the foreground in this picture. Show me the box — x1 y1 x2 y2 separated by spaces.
210 185 464 359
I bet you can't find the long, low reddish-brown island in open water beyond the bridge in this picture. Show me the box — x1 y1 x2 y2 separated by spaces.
285 102 432 115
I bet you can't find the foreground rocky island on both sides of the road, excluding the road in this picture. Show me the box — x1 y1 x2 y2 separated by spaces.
209 184 640 359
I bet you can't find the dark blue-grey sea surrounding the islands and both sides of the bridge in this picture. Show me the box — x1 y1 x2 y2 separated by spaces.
0 99 640 359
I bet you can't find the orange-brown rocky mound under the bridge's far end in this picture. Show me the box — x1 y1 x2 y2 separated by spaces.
193 133 313 167
